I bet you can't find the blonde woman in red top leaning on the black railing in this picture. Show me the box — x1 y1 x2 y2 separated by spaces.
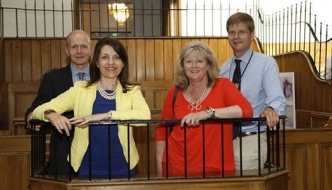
156 42 252 176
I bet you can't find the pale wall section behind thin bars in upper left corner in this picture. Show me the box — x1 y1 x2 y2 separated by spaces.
1 0 73 37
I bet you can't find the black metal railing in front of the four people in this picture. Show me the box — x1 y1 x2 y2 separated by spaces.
31 116 286 182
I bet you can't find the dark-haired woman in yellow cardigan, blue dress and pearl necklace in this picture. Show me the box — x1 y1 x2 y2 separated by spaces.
33 37 151 176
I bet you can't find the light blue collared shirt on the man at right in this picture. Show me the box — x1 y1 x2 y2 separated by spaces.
220 49 286 132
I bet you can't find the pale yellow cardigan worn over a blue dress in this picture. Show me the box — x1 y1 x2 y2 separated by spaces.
32 81 151 171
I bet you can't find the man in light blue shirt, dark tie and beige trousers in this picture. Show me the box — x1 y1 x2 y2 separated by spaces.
220 12 286 170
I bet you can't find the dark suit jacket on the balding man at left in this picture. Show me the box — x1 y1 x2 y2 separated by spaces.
25 64 74 175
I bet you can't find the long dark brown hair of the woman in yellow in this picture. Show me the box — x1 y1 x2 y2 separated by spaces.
87 37 135 93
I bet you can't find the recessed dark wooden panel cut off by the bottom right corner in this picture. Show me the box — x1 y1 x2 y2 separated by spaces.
320 143 332 189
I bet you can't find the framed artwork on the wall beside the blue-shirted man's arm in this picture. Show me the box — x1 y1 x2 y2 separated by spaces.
280 72 296 129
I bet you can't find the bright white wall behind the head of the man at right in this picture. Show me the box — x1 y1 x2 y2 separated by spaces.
181 0 332 39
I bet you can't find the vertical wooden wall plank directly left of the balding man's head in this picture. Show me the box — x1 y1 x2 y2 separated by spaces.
50 39 65 68
